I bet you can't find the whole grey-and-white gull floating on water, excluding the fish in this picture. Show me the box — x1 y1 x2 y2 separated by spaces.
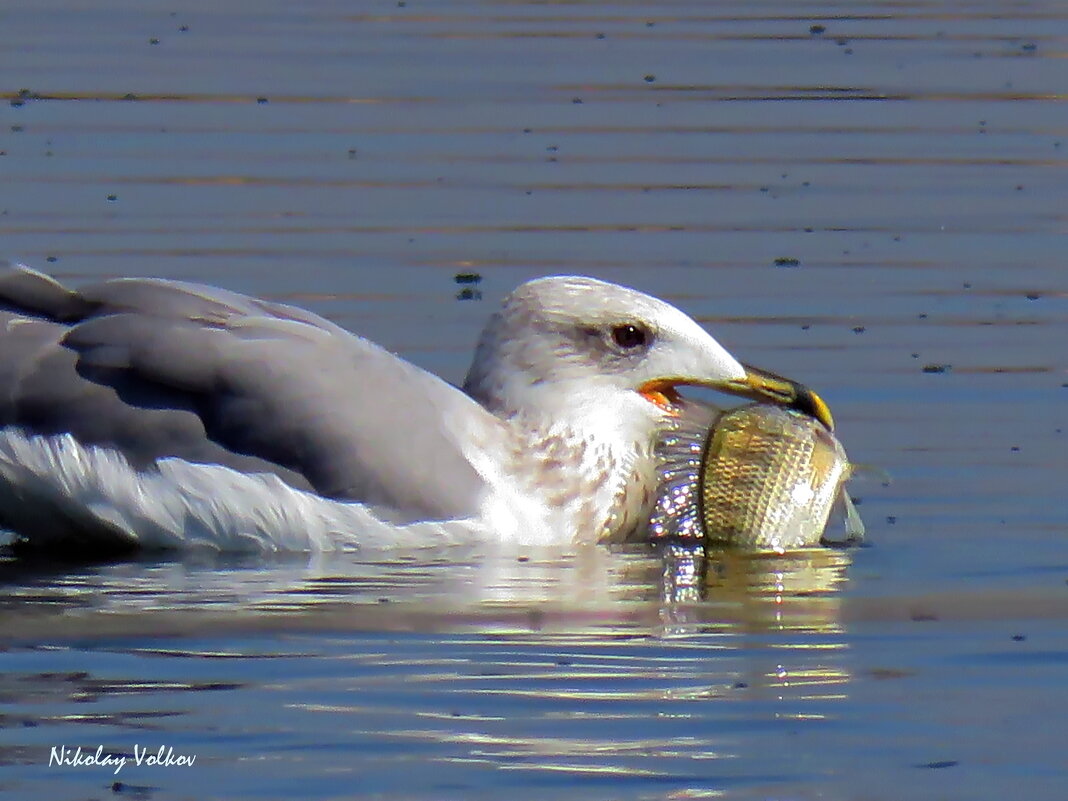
0 264 831 554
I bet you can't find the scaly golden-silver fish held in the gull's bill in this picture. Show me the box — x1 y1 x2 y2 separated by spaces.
648 404 864 553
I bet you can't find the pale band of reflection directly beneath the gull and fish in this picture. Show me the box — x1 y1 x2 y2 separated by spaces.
0 544 849 637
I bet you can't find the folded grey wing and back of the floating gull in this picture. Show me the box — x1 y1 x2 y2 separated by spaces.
0 266 499 520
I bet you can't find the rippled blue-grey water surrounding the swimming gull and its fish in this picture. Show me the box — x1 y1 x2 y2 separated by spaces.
0 0 1068 800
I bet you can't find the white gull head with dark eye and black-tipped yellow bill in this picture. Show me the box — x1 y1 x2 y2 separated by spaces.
464 277 831 437
